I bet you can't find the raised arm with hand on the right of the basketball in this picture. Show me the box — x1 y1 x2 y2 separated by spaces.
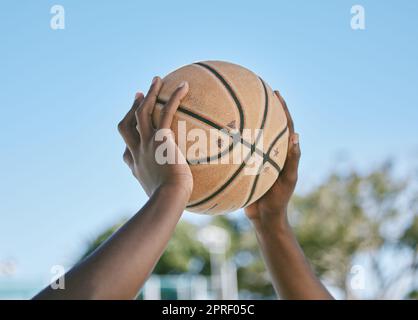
245 91 333 299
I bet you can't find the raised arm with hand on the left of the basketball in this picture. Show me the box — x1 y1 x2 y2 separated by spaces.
34 78 193 299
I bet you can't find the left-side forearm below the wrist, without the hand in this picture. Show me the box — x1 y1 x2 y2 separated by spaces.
35 187 188 299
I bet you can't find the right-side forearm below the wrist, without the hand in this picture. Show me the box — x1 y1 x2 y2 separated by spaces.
253 213 332 299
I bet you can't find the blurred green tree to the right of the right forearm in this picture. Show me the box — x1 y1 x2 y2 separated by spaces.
291 163 418 298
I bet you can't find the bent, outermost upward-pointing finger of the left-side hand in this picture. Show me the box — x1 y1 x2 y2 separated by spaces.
118 92 144 151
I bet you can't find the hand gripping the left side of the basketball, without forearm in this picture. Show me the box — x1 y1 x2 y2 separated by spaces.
118 77 193 200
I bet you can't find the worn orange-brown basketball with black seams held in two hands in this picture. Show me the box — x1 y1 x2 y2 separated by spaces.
152 61 289 215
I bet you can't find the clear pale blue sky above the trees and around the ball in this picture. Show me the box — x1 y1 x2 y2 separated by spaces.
0 0 418 288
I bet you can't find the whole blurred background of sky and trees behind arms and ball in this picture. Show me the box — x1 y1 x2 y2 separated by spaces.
0 0 418 299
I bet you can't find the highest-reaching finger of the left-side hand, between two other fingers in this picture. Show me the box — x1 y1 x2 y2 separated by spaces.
135 77 162 139
